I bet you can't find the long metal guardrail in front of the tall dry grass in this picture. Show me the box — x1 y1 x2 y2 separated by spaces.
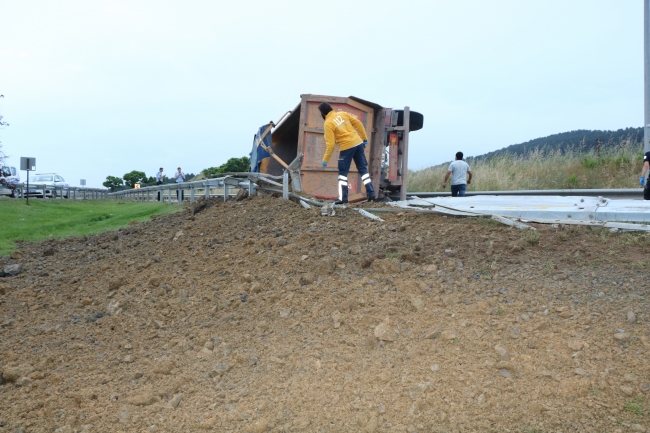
406 188 643 200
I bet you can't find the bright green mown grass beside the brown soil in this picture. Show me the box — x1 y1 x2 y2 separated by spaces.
0 199 182 255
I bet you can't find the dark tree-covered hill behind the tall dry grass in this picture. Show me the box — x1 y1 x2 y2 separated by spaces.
472 128 643 163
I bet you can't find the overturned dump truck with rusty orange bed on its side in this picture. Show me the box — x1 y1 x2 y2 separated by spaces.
251 94 424 202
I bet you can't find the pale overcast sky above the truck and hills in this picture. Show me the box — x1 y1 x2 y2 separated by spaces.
0 0 643 186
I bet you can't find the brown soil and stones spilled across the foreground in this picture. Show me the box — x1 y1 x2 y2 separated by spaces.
0 196 650 433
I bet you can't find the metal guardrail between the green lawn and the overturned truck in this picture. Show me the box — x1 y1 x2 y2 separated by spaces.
107 173 289 205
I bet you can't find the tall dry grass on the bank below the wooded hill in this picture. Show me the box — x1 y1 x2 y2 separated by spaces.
408 141 643 192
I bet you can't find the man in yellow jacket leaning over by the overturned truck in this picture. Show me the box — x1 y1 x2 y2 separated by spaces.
318 102 375 204
